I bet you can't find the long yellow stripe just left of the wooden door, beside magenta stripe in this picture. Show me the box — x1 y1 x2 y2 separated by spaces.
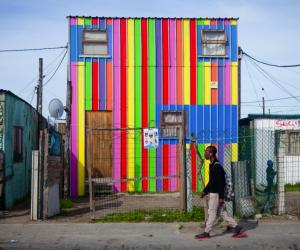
77 62 85 196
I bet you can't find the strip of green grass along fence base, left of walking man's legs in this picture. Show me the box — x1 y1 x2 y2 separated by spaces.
93 207 204 222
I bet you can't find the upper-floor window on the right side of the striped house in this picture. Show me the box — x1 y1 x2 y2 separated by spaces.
201 30 226 57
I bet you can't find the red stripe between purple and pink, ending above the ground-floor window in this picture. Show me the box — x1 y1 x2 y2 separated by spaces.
162 19 169 105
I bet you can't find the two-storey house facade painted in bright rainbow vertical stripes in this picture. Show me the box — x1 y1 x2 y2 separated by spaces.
68 16 239 196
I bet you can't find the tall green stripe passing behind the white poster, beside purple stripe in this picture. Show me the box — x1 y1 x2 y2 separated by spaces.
148 19 156 192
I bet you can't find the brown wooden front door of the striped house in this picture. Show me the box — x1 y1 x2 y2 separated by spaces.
86 111 112 178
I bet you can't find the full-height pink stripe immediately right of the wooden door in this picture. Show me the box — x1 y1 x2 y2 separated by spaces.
113 19 121 191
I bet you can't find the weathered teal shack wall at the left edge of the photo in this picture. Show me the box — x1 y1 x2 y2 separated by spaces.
1 93 37 208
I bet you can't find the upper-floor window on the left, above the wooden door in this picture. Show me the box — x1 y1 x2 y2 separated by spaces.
82 29 108 56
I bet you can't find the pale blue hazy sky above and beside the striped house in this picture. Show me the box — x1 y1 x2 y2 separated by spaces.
0 0 300 116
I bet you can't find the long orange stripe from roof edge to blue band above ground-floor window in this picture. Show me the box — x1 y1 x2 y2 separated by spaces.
176 19 183 105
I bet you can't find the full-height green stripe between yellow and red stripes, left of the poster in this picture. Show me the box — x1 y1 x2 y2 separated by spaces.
134 19 142 191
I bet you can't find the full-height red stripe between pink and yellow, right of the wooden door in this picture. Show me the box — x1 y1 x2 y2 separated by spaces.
120 19 127 192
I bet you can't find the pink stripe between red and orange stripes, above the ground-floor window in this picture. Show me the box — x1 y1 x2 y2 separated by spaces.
169 19 176 104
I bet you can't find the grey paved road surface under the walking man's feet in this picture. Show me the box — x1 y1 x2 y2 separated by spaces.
0 221 300 250
